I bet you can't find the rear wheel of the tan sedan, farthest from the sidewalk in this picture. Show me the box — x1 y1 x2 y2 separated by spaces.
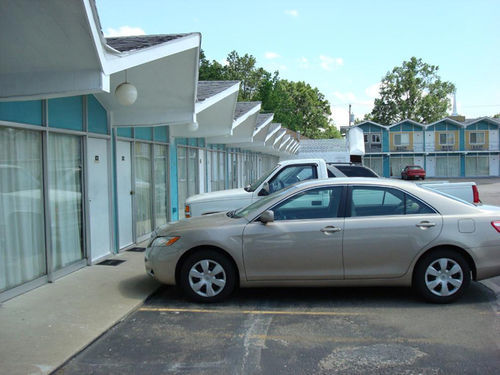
413 249 471 303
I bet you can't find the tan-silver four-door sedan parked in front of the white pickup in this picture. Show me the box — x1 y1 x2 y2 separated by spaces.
145 178 500 303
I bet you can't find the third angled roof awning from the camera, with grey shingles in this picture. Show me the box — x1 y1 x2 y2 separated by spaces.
207 102 261 144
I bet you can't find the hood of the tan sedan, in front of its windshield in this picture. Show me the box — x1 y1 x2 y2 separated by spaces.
154 212 248 236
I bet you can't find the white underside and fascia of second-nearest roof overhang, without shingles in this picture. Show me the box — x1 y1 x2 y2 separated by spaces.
170 82 240 138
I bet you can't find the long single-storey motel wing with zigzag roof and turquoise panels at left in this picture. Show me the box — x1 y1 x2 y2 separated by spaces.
0 0 299 302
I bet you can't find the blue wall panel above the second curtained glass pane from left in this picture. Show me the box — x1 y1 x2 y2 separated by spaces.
48 96 83 130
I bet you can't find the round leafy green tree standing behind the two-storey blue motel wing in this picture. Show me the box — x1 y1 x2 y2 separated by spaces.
366 57 455 125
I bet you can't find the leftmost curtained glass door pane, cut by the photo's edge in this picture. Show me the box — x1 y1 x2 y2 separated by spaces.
0 127 47 292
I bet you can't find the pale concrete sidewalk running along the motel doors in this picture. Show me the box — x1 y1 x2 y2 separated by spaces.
0 252 160 375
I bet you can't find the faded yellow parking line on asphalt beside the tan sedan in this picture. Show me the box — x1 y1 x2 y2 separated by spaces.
139 307 367 316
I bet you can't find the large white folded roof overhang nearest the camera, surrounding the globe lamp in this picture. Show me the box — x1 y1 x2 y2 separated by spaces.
0 0 201 126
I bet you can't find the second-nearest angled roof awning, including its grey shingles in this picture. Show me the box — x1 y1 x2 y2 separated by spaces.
170 81 240 138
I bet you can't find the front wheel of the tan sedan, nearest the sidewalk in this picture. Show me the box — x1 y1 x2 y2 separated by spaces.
179 249 236 303
